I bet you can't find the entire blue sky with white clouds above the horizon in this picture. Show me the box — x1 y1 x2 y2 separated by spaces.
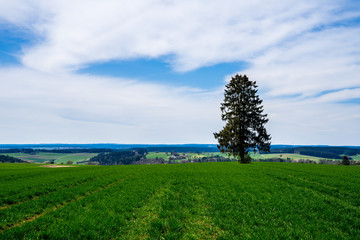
0 0 360 146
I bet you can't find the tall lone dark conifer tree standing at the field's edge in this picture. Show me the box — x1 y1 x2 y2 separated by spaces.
214 74 271 163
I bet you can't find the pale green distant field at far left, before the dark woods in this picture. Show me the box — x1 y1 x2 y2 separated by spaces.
4 152 97 163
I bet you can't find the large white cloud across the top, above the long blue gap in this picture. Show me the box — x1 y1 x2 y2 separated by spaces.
3 0 348 72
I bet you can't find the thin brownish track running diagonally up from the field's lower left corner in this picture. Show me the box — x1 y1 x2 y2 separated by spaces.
0 174 138 233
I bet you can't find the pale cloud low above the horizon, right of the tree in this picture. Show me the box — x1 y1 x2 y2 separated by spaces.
264 95 360 146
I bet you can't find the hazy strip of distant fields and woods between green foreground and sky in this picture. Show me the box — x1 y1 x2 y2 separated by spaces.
0 144 360 165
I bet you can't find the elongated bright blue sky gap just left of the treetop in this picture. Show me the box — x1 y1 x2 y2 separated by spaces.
78 57 247 90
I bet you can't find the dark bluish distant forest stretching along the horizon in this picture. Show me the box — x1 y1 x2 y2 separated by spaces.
0 144 360 165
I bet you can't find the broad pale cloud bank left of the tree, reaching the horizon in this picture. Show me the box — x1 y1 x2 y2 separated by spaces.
0 68 221 143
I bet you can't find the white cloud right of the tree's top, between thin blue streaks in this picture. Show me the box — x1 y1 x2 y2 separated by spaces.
249 27 360 97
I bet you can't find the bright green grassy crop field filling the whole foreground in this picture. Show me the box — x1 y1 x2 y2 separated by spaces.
0 162 360 239
